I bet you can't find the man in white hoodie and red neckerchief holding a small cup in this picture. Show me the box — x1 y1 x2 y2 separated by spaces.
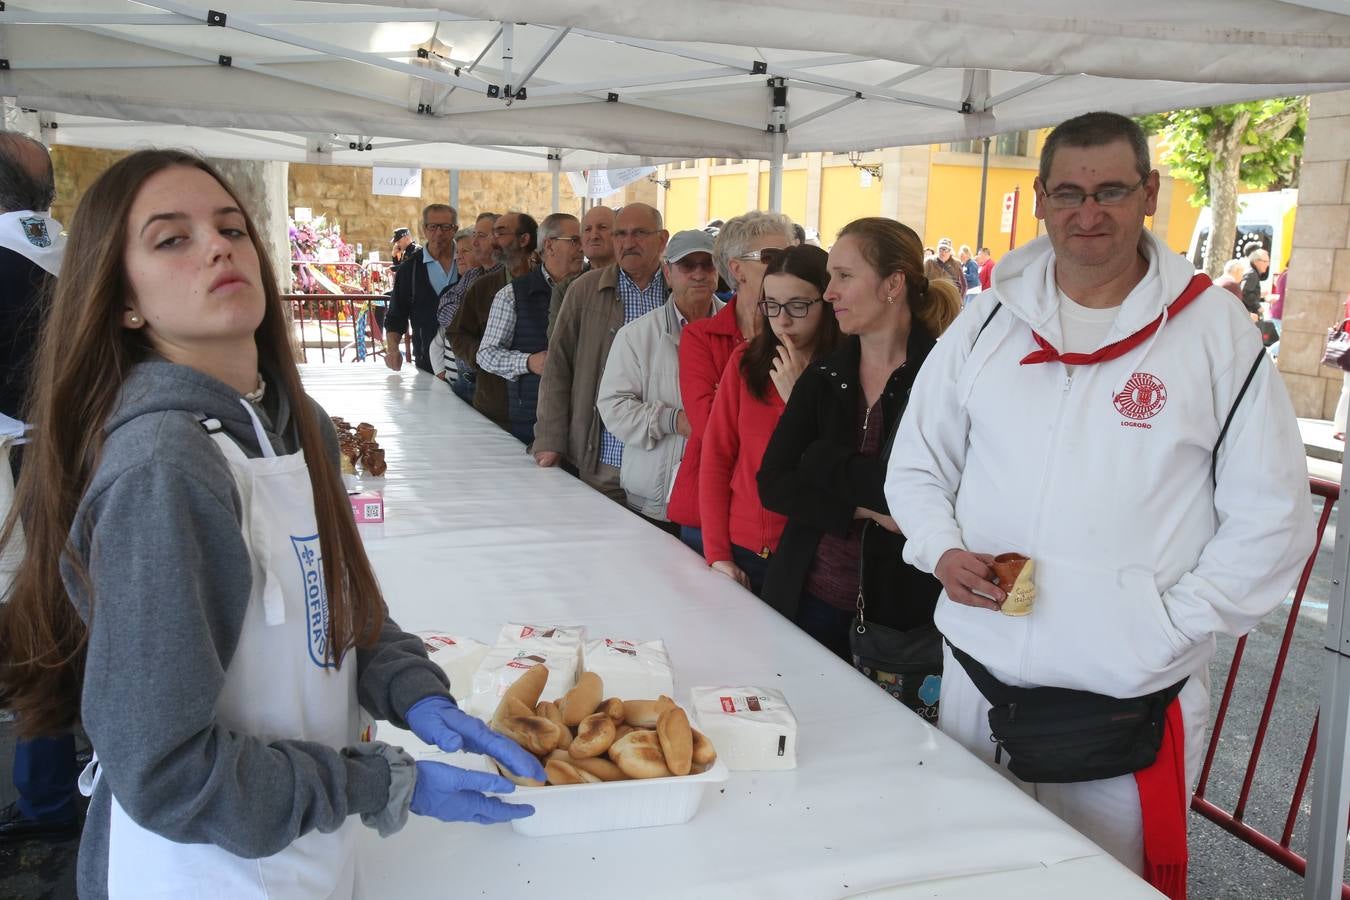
886 112 1314 896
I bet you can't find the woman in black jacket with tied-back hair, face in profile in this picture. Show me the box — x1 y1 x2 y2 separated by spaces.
759 219 961 701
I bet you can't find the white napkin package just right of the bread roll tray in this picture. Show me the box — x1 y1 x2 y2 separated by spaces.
691 687 797 772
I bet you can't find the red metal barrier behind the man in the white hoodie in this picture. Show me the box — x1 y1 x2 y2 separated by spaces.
1191 478 1350 900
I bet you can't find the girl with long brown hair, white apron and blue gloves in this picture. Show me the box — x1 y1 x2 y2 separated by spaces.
0 150 543 897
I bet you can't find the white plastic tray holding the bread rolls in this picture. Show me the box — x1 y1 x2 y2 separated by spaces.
505 758 730 838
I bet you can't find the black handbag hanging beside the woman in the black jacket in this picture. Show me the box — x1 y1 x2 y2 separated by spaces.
848 522 942 723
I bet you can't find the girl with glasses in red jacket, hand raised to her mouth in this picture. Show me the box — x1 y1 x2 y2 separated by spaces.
698 246 840 595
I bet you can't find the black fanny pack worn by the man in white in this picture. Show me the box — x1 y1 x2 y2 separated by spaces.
948 642 1187 784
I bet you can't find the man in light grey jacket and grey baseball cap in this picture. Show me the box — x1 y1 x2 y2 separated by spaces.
595 231 722 536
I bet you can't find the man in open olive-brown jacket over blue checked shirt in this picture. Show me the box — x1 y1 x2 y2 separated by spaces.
533 204 670 503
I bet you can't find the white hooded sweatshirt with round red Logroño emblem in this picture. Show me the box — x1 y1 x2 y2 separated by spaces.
886 232 1314 698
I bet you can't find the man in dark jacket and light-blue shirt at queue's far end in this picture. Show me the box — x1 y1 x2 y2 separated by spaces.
385 204 459 375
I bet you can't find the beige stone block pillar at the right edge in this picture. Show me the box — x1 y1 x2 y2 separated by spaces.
1280 90 1350 418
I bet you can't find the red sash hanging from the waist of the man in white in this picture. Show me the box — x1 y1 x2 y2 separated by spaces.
1134 699 1191 900
